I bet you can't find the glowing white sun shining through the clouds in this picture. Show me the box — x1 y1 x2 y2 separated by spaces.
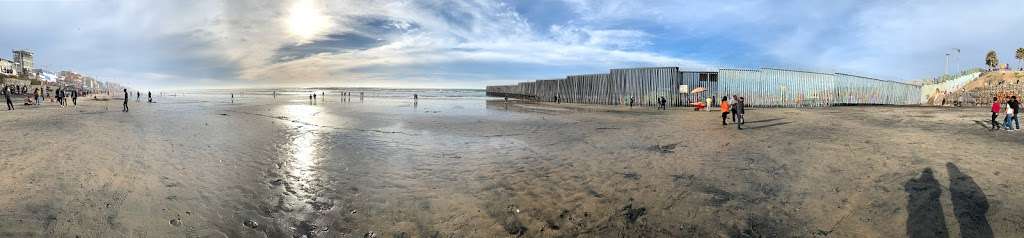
285 0 333 44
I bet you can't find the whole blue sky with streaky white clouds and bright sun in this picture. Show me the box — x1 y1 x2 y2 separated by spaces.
0 0 1024 89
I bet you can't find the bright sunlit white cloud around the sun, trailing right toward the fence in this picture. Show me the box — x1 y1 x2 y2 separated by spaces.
190 0 703 85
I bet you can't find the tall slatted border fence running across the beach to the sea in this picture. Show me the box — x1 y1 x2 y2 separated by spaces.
486 67 922 107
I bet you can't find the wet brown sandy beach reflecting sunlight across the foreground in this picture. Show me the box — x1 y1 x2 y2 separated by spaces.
0 96 1024 237
